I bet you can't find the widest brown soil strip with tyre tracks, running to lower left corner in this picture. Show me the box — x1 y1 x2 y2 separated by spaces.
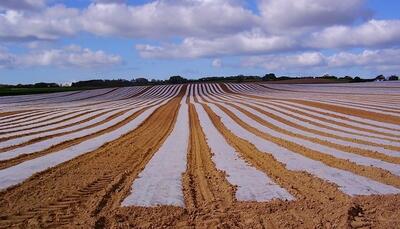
0 91 184 227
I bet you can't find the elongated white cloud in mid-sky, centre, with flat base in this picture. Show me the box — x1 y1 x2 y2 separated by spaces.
136 31 295 58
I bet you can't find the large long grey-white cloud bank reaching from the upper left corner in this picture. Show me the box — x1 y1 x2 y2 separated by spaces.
0 0 257 41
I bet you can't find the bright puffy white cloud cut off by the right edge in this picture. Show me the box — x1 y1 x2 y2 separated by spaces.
308 20 400 48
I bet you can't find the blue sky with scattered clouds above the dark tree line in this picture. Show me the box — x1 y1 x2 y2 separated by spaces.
0 0 400 84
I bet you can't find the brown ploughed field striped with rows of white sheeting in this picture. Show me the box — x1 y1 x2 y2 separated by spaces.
0 82 400 228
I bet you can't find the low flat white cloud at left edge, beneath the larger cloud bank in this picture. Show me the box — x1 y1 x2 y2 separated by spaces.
0 45 122 68
